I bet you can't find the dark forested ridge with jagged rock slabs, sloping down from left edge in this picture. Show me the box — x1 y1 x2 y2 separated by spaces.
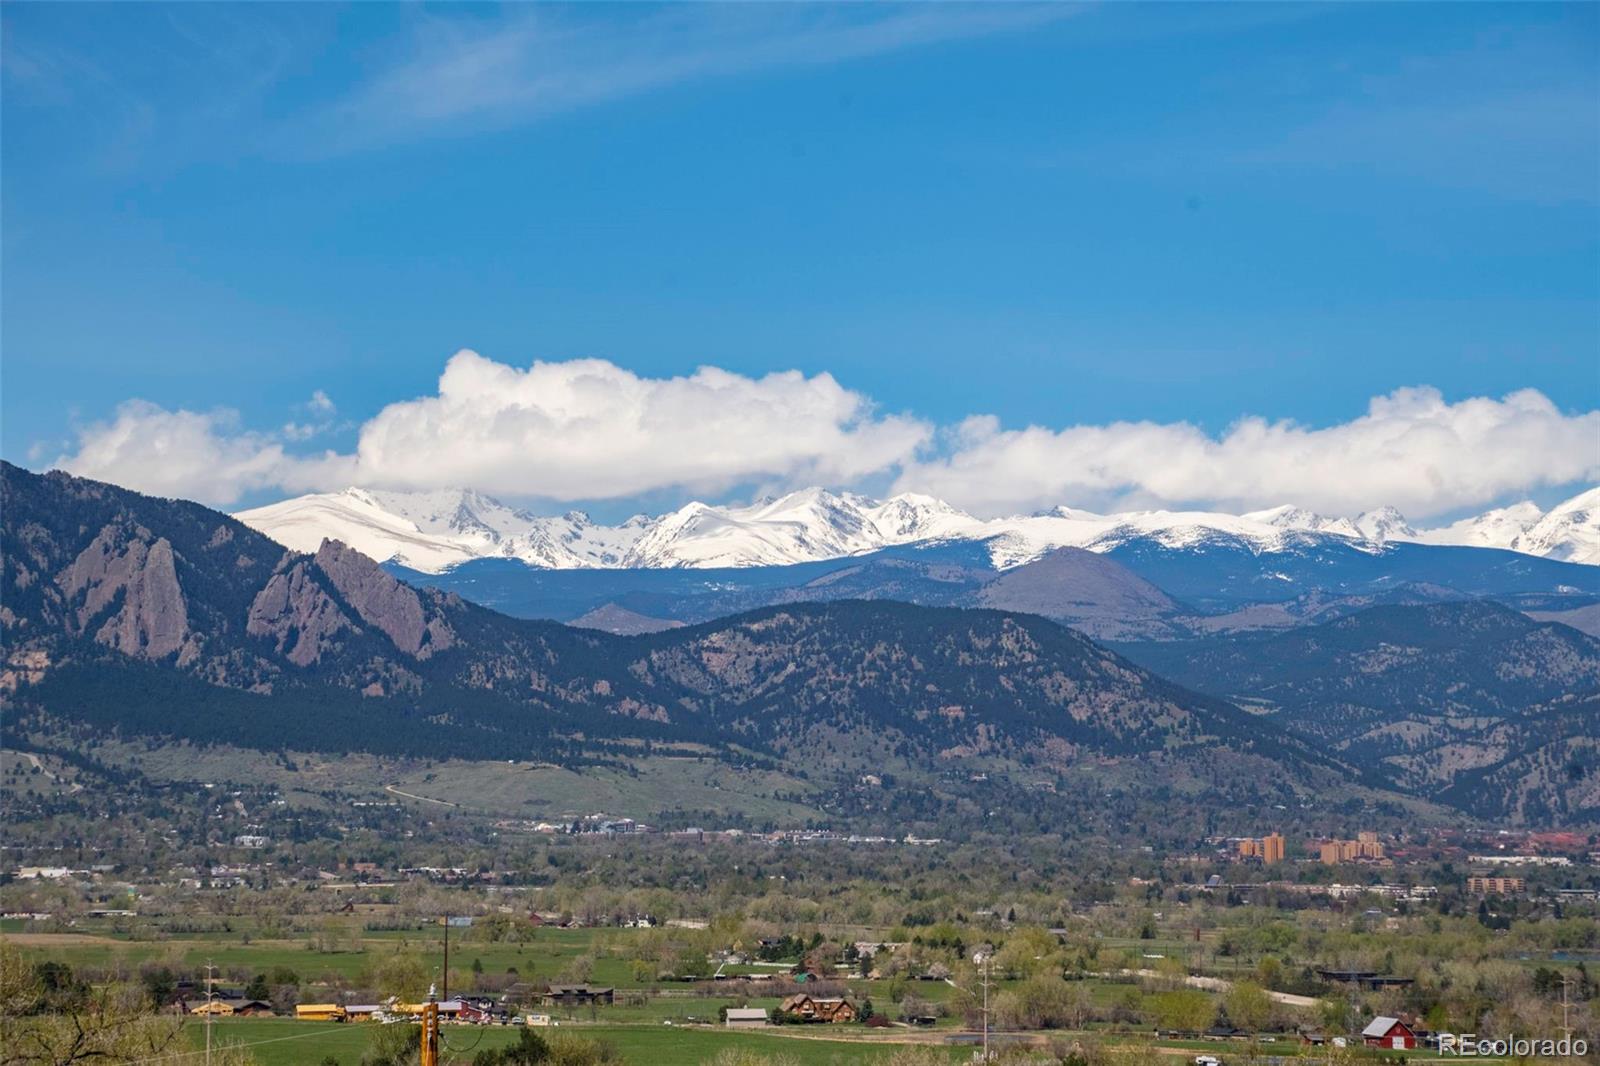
0 464 1317 777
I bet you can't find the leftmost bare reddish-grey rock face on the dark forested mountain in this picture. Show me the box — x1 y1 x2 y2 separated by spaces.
56 523 189 659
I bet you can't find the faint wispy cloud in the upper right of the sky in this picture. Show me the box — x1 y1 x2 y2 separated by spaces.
1034 22 1600 205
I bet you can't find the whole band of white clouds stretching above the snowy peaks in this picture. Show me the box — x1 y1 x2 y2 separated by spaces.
58 361 1600 519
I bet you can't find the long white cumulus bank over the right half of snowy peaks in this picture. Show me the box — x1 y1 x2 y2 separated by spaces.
898 387 1600 517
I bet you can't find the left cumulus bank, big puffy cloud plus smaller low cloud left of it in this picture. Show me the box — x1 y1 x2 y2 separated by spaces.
58 351 933 504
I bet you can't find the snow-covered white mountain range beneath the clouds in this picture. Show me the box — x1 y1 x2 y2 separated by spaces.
237 488 1600 573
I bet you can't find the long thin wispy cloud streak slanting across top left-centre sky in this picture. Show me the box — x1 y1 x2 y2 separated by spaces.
272 3 1083 154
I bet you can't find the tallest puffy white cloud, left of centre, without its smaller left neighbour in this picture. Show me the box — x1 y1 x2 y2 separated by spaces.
345 351 931 499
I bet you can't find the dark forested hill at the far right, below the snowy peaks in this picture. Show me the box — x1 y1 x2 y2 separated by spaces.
1118 600 1600 821
